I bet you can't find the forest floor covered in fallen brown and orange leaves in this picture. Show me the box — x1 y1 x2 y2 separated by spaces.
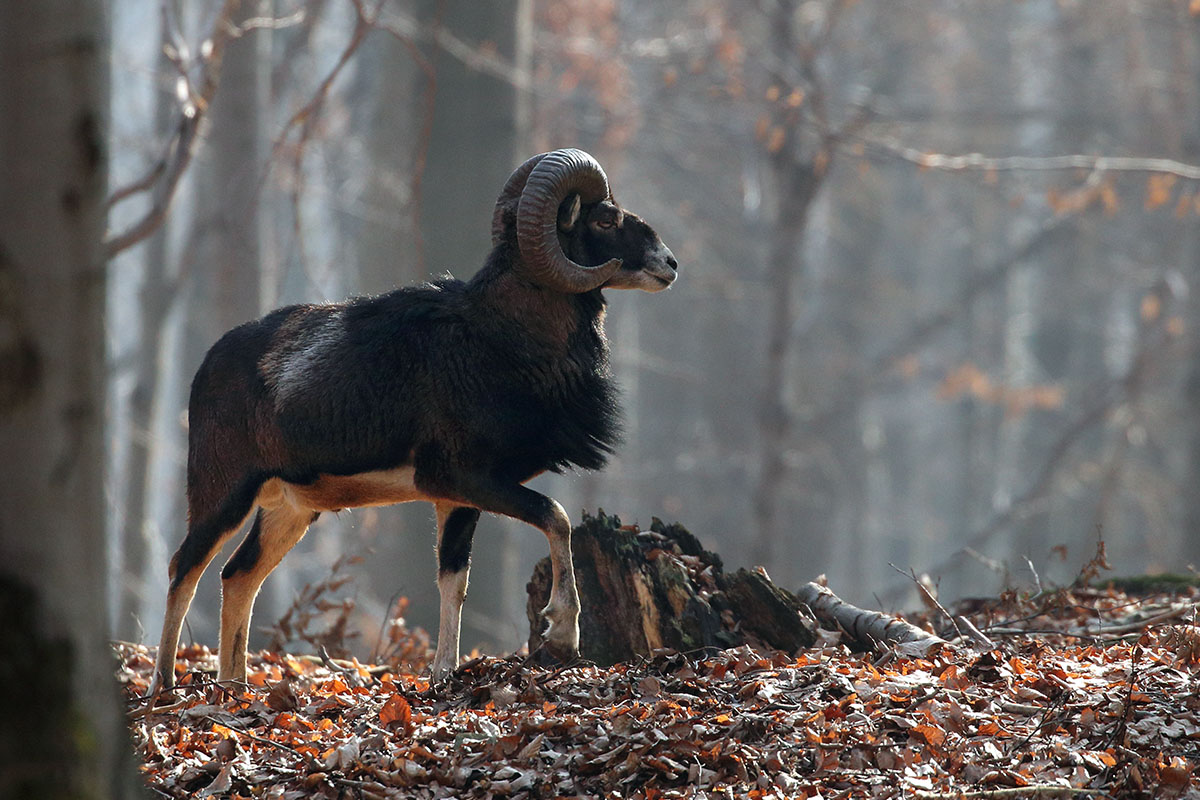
116 568 1200 800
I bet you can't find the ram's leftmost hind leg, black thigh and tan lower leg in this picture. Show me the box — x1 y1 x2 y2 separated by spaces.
150 503 251 692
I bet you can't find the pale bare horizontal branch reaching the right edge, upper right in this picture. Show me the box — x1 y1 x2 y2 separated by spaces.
857 137 1200 181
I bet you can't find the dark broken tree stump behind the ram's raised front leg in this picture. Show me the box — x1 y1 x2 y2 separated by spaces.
526 511 816 667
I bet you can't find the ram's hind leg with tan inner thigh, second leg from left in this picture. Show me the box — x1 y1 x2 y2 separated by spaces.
217 501 319 680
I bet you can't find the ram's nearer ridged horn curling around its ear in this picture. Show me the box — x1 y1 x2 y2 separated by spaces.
517 150 620 294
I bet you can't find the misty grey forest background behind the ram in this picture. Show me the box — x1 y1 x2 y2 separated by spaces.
106 0 1200 656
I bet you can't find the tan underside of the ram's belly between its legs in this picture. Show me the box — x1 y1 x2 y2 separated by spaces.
258 467 430 511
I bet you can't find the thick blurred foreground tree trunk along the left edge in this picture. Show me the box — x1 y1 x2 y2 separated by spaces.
0 0 139 799
